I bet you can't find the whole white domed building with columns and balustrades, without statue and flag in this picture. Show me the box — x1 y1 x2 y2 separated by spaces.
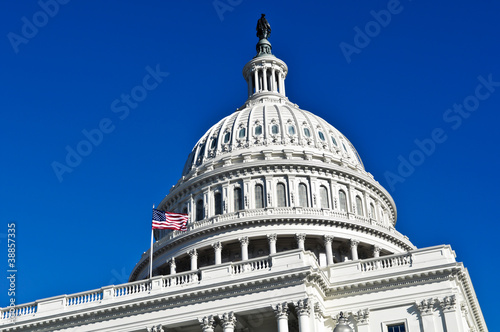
0 23 488 332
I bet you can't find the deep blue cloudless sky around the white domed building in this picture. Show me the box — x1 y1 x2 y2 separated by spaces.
0 0 500 331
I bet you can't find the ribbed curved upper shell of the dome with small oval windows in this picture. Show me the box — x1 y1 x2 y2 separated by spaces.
183 100 364 180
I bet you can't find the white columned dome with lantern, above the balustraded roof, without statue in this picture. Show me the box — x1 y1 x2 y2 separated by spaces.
130 25 415 281
